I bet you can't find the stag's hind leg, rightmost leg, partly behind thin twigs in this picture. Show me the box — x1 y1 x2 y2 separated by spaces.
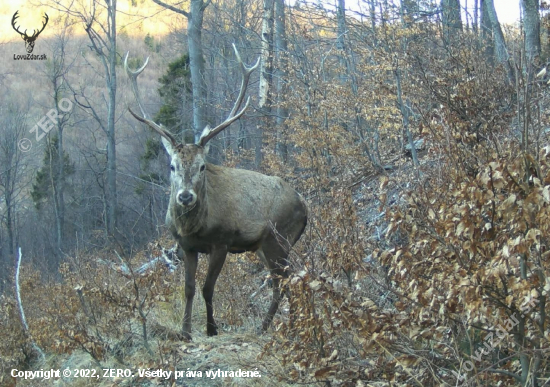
257 246 294 332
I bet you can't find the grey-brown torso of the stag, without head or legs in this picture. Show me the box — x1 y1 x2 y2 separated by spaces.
166 164 306 253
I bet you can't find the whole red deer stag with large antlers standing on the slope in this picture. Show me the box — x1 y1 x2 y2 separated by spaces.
124 45 307 339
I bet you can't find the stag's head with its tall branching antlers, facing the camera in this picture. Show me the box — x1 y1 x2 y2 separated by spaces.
124 45 260 211
